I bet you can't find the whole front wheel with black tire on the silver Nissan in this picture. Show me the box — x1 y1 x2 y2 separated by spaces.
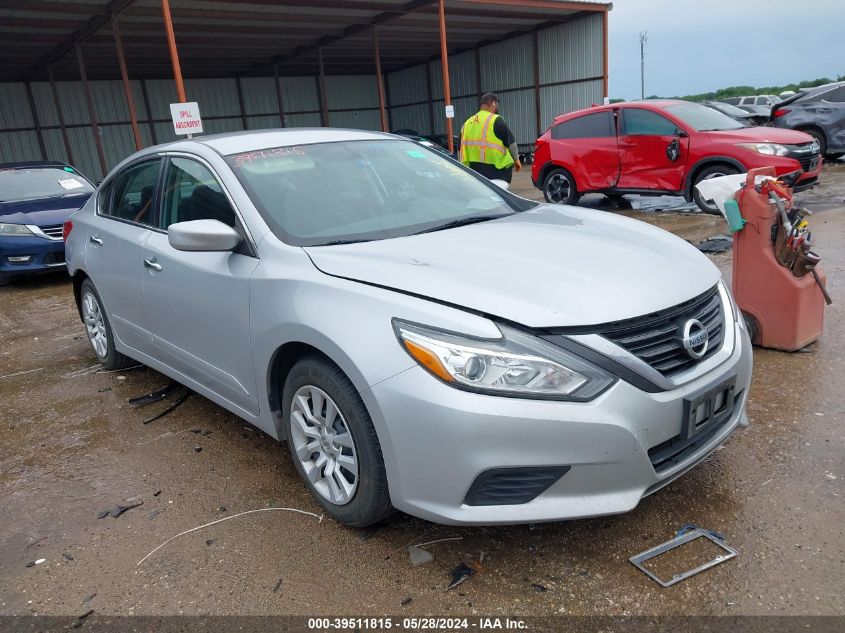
282 355 393 527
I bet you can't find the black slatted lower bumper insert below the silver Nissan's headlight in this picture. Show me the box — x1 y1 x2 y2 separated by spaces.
464 466 571 506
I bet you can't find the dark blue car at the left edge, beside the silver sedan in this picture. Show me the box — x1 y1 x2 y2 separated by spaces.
0 161 94 286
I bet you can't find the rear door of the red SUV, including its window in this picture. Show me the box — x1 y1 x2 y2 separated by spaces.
550 110 619 191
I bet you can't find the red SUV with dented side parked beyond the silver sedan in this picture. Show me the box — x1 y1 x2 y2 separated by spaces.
531 100 822 213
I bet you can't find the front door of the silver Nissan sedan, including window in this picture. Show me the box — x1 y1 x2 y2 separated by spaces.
142 156 258 415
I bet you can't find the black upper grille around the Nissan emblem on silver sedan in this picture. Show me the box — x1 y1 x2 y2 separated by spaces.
600 288 725 376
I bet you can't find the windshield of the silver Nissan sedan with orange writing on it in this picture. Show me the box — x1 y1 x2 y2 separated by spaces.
227 139 534 246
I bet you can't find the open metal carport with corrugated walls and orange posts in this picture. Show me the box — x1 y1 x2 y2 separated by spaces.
0 0 612 176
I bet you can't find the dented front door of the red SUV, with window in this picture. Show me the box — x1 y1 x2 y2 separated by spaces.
618 107 689 191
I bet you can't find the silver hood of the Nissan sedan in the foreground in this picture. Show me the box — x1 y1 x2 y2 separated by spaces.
304 205 721 327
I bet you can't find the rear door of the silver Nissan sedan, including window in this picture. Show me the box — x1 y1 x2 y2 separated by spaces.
85 157 162 356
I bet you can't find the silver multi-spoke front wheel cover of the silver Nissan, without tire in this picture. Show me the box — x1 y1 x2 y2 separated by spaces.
290 385 358 505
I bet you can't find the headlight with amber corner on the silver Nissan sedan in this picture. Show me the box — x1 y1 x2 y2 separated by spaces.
393 319 615 402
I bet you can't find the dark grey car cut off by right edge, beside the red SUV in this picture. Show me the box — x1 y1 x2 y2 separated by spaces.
772 81 845 159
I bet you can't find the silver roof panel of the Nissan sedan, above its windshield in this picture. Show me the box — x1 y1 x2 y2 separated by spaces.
147 127 401 156
